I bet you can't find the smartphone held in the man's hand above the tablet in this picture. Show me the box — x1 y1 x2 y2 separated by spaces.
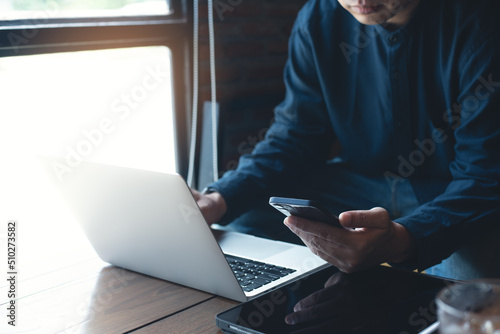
269 197 343 228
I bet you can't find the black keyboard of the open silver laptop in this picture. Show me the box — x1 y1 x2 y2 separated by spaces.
226 255 296 292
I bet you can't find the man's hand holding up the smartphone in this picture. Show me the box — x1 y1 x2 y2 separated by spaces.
284 208 416 273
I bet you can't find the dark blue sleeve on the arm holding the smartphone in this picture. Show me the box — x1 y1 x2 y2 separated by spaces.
396 30 500 270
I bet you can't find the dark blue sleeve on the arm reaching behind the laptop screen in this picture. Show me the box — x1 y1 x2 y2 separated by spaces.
210 15 335 221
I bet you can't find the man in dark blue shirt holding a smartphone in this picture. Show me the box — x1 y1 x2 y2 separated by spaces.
195 0 500 279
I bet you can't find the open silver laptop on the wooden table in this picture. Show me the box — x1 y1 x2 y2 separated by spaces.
39 157 329 301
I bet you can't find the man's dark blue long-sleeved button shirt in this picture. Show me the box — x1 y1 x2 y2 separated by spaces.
212 0 500 269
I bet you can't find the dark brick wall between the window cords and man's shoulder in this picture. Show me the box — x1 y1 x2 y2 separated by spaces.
196 0 306 176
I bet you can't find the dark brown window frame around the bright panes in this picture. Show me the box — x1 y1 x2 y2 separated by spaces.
0 0 193 177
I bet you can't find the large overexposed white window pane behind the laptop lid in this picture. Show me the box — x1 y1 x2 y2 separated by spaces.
0 46 176 172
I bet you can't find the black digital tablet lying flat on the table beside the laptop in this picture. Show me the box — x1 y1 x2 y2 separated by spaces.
216 266 454 334
